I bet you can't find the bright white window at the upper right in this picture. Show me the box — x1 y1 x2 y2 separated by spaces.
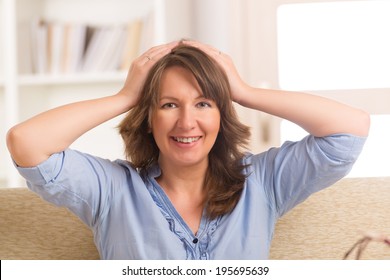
277 1 390 90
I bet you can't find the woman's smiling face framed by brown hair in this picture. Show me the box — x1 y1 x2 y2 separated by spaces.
151 66 220 170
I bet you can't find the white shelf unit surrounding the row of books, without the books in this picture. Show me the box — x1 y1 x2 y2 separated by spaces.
0 0 165 187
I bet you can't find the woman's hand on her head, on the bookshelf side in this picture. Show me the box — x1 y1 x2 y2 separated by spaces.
118 41 179 109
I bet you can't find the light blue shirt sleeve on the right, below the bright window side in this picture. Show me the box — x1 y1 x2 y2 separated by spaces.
250 134 366 216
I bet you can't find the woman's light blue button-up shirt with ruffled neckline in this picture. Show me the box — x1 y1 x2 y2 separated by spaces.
18 134 365 259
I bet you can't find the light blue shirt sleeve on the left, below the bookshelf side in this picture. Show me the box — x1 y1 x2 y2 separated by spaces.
17 149 124 227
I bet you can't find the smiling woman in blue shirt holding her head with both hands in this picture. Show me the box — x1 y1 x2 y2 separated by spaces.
7 41 369 259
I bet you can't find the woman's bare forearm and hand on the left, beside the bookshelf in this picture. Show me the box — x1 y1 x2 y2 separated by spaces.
7 42 177 167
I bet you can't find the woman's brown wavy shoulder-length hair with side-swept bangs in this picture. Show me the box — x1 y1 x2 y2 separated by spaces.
119 44 250 219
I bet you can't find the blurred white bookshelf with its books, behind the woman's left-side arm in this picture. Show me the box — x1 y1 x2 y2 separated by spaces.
0 0 165 187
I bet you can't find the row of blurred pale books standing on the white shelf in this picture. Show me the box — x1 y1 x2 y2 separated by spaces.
31 19 144 75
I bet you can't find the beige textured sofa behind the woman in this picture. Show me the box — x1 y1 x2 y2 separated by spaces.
0 178 390 260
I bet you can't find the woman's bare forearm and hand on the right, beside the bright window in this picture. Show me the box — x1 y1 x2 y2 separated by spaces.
183 41 370 137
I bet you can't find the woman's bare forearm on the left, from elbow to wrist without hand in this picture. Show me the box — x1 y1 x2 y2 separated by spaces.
7 94 130 167
